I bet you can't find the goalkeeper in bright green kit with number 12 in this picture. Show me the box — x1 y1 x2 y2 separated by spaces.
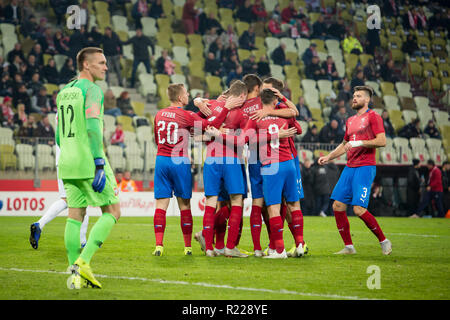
56 47 120 289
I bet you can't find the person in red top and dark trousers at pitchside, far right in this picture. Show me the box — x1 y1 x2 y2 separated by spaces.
410 159 445 218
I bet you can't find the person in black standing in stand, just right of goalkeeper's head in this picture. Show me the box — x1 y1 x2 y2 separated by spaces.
102 27 123 87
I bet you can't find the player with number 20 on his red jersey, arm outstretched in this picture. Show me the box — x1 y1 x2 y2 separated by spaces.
153 84 243 256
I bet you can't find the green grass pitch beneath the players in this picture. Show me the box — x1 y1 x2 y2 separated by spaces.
0 216 450 300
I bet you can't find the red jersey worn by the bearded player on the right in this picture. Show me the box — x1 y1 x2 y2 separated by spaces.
344 109 384 167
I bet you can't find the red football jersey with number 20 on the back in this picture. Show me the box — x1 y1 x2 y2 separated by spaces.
154 107 228 157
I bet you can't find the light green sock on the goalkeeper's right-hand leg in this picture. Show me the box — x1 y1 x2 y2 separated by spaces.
78 212 117 264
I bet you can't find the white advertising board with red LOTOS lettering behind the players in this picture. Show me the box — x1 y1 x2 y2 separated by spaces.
0 191 252 217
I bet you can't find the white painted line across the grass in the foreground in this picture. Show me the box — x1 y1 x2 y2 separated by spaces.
0 267 382 300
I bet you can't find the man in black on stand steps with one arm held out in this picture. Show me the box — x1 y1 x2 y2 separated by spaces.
121 29 155 88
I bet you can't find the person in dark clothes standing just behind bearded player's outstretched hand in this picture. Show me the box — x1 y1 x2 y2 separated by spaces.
312 161 331 217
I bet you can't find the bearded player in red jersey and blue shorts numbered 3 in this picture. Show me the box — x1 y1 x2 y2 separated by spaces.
319 86 392 255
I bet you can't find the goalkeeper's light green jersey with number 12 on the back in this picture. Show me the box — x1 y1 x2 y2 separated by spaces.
56 79 106 179
